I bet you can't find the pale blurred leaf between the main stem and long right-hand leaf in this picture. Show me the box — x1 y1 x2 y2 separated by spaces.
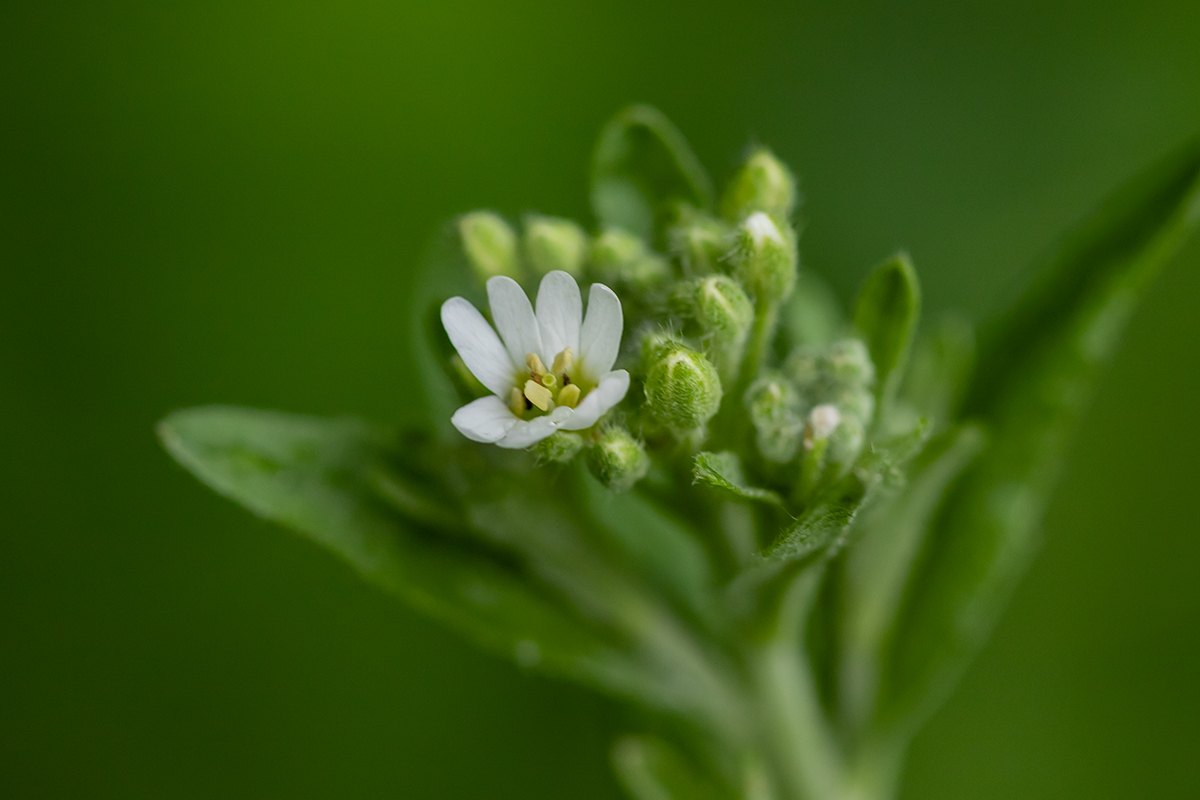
838 426 985 729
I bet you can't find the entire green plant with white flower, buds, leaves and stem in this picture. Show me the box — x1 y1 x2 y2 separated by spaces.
160 107 1200 800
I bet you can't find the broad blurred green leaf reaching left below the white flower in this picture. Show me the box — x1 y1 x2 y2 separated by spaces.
158 407 656 693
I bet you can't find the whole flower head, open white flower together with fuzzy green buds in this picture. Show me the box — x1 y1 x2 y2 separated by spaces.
442 143 875 493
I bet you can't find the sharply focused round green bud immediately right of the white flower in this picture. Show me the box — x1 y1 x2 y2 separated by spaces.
646 343 721 434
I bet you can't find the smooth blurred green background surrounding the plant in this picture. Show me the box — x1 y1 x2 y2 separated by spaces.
0 0 1200 800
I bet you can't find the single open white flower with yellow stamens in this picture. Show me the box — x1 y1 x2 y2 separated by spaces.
442 271 629 450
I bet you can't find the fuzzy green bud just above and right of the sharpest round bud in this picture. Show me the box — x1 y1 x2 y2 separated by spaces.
671 275 754 383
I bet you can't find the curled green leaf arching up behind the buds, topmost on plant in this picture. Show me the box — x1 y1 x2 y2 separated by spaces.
592 106 713 242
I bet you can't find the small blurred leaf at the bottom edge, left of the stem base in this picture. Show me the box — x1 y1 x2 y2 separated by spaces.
612 736 733 800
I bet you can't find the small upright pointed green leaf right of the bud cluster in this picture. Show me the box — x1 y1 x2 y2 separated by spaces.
854 253 920 405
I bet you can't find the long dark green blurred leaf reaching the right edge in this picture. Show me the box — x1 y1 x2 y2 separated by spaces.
887 136 1200 736
